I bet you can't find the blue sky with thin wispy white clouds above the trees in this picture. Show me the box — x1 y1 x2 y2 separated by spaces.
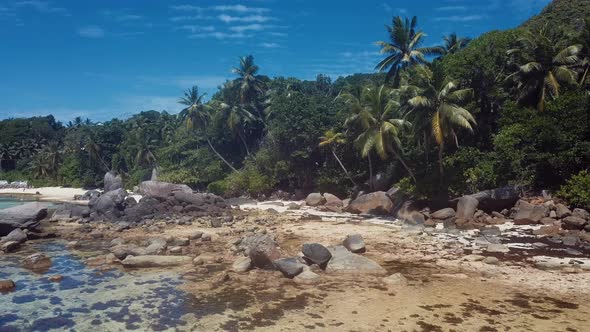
0 0 550 121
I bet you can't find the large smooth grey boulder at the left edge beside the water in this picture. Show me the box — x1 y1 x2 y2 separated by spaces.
0 202 50 236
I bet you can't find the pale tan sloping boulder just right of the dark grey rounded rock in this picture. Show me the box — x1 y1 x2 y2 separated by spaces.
326 246 387 275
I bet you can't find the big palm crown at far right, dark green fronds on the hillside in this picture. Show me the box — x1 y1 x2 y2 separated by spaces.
507 27 582 111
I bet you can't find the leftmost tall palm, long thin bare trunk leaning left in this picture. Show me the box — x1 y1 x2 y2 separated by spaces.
178 86 238 172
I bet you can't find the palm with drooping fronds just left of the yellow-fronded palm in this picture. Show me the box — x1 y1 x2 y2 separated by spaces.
341 85 416 181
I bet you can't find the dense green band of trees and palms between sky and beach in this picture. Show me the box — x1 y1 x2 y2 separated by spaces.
0 0 590 207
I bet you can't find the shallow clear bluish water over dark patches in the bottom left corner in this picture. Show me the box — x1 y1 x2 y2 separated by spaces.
0 241 199 331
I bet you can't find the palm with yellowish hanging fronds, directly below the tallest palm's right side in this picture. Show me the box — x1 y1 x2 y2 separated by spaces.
405 66 476 181
